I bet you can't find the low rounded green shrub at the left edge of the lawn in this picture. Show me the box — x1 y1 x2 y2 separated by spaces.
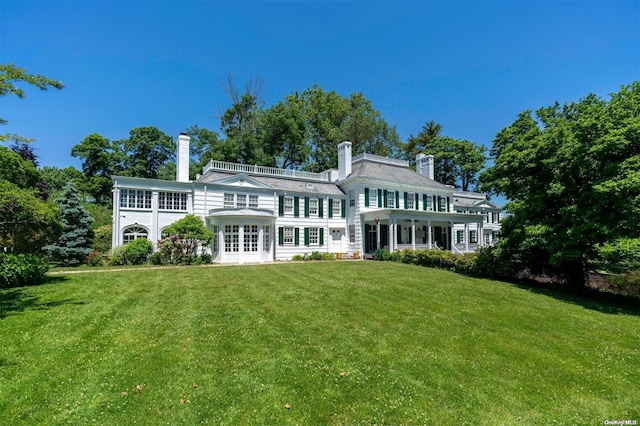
0 253 49 288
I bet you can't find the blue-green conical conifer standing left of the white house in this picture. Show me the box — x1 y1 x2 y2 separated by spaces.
44 183 94 266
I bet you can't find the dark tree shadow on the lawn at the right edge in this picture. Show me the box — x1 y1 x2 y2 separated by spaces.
511 282 640 316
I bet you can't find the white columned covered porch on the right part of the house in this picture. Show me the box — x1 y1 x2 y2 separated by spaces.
362 210 482 254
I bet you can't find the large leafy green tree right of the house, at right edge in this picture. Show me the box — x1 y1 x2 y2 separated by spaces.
481 82 640 287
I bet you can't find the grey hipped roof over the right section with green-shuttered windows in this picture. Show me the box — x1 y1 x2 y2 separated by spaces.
340 161 453 191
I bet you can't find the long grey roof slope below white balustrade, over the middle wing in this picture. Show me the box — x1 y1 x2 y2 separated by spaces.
196 170 344 196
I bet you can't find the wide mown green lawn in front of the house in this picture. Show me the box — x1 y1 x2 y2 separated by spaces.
0 261 640 425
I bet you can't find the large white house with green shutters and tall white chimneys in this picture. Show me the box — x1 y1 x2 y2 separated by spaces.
112 134 502 263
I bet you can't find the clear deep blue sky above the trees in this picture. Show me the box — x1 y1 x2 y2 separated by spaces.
0 0 640 172
